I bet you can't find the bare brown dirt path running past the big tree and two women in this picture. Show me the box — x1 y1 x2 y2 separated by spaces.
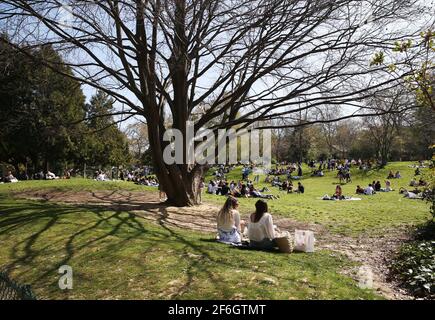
14 191 413 299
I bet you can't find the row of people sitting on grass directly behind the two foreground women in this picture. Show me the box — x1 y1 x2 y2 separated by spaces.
207 180 279 200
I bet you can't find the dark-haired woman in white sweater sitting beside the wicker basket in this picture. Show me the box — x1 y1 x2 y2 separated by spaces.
248 200 276 250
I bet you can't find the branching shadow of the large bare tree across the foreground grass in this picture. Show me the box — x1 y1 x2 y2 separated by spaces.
0 201 320 299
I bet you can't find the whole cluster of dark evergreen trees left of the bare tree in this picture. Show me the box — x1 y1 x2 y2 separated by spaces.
0 42 133 174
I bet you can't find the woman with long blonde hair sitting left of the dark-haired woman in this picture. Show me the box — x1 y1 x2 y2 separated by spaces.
217 196 242 243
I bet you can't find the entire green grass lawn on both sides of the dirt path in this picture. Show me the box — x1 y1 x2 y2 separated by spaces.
0 163 429 299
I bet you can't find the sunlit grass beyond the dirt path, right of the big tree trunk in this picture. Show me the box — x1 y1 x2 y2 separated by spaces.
204 163 430 236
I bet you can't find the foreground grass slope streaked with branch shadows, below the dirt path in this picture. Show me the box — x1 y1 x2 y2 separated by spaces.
0 198 379 299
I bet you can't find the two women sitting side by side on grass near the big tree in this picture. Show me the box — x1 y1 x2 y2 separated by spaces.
217 196 277 250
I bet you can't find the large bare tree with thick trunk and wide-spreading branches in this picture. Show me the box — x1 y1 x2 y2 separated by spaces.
0 0 433 206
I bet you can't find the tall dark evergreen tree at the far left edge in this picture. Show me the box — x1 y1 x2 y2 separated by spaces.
0 43 85 171
